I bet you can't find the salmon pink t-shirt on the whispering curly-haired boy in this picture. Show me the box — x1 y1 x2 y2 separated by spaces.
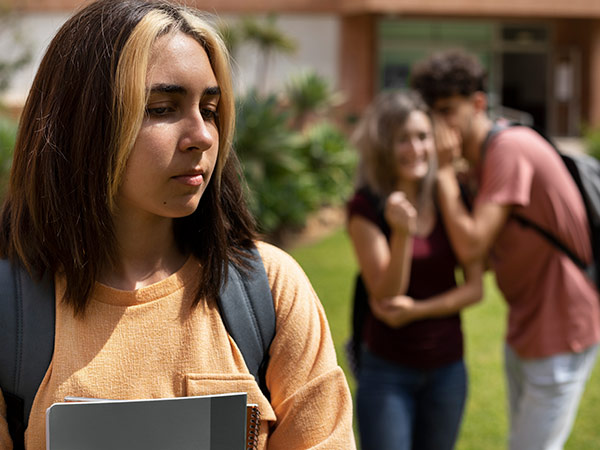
475 127 600 358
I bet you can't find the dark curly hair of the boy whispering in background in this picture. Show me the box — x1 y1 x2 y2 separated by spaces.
411 49 487 107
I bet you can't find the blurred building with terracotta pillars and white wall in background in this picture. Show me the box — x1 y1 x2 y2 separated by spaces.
5 0 600 136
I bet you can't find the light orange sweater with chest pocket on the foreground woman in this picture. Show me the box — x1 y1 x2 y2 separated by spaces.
0 243 355 450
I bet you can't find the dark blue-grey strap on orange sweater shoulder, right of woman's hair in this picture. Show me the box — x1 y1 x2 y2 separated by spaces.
219 249 275 398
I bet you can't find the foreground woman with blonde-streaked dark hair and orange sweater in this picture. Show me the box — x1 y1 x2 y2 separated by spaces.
0 0 354 450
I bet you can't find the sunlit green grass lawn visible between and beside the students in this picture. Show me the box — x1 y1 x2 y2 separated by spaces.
290 230 600 450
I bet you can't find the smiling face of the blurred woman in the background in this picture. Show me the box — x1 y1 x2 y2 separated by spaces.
394 111 435 181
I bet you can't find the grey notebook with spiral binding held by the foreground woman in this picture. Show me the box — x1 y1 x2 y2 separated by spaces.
46 392 260 450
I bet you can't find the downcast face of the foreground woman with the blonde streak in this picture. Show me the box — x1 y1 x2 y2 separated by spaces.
117 32 220 218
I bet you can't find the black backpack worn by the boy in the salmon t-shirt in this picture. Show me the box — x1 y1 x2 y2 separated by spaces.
481 123 600 292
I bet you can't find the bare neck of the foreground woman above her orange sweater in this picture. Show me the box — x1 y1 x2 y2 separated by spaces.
99 215 187 291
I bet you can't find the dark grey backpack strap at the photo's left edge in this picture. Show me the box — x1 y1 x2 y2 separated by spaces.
0 260 55 450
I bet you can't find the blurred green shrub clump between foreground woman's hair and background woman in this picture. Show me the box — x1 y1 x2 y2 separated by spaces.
234 93 354 238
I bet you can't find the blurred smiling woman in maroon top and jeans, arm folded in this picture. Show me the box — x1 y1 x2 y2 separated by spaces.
348 92 482 450
